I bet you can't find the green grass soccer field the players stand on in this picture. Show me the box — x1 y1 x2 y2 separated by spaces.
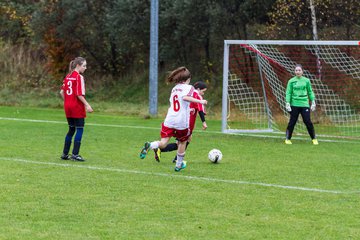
0 107 360 240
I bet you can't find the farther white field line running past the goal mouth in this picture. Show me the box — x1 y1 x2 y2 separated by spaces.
0 117 360 144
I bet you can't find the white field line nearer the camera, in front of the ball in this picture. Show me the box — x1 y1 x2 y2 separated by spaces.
0 157 360 194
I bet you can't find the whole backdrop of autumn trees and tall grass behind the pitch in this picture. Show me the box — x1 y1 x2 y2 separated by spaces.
0 0 360 114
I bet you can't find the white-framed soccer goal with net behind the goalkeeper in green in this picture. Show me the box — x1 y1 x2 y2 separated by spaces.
221 40 360 137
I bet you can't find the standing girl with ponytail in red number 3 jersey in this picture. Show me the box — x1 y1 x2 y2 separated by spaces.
60 57 93 161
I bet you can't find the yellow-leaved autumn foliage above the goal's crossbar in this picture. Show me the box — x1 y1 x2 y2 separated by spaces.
260 0 360 40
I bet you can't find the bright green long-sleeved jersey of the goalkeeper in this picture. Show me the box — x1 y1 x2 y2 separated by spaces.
286 76 315 107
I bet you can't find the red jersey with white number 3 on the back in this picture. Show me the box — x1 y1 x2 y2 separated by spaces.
61 71 86 118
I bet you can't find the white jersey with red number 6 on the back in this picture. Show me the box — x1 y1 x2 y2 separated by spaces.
164 83 194 130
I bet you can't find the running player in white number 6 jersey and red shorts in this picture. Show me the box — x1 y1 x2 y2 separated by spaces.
140 67 207 172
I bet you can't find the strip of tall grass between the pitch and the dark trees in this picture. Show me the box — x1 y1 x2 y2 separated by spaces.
0 38 221 114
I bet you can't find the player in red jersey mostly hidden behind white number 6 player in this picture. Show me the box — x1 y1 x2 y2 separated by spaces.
154 81 207 162
